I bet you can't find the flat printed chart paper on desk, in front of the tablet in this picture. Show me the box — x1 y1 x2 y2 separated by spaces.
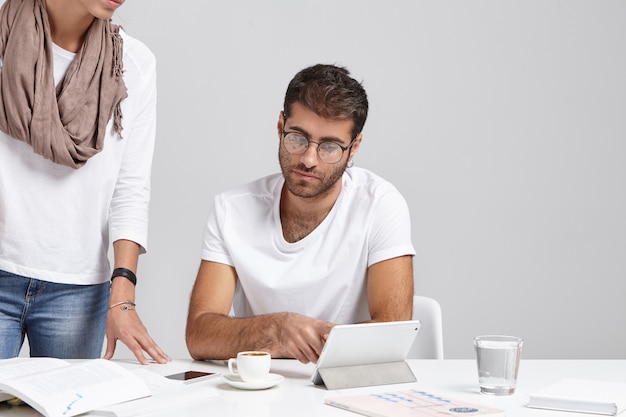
325 389 505 417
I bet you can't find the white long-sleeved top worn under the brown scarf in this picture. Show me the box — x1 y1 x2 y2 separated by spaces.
0 31 156 284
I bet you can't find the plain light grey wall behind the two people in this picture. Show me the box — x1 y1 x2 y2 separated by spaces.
105 0 626 359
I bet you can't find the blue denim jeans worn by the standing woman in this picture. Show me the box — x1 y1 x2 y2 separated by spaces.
0 271 110 359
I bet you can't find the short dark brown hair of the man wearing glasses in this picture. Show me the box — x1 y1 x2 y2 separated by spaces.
283 64 369 137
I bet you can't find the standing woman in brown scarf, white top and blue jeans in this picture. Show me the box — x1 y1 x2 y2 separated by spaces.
0 0 169 363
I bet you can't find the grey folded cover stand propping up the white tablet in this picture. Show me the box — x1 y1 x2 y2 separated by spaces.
317 361 417 390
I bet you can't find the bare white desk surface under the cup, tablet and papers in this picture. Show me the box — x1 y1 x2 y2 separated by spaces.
0 360 626 417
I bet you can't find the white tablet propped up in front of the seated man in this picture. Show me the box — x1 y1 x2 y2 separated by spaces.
311 320 421 385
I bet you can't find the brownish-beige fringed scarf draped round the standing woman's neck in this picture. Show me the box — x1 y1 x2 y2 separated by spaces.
0 0 127 168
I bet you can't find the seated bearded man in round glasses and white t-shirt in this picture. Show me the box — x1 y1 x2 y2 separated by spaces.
186 65 415 363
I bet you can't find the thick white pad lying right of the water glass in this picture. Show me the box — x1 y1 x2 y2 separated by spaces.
528 376 626 416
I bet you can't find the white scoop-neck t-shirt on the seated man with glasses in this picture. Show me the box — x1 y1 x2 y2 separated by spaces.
202 168 415 323
